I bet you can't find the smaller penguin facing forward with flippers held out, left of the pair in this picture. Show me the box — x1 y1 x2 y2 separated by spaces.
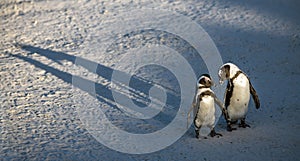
189 74 225 139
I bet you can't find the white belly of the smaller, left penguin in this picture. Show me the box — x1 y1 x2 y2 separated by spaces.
197 96 215 126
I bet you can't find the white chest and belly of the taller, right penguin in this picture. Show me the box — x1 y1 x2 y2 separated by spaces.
227 74 250 120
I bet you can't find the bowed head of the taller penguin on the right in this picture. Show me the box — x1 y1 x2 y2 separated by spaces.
218 63 240 84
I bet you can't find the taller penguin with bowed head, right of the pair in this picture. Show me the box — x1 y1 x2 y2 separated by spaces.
218 63 260 131
